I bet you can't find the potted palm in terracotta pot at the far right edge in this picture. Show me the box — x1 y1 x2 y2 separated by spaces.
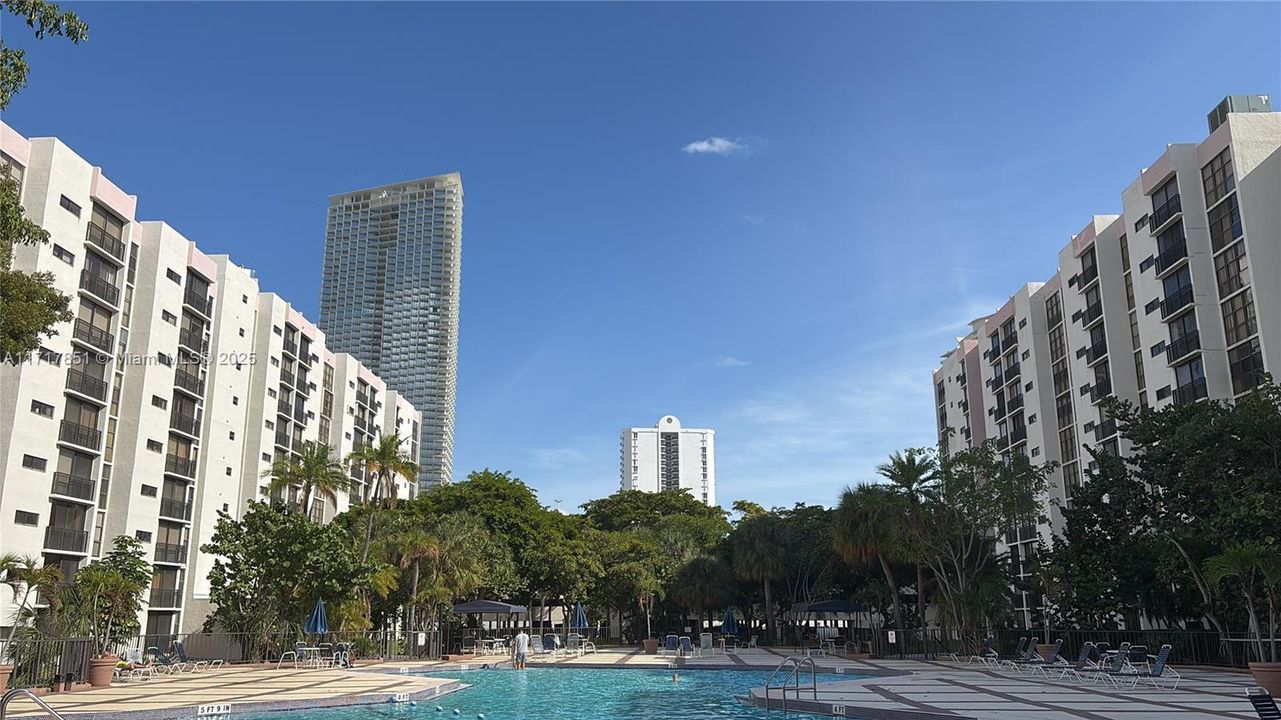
1205 541 1281 696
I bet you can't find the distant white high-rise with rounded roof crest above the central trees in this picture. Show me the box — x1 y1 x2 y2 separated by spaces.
620 415 716 505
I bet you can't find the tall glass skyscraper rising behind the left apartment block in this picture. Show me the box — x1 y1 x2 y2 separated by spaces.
320 173 462 487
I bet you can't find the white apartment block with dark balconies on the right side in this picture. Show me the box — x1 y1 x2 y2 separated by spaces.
934 96 1281 622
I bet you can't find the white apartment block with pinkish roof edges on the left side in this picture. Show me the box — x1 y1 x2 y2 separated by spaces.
0 124 421 637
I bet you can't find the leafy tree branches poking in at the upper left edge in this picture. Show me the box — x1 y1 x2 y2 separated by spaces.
0 0 88 363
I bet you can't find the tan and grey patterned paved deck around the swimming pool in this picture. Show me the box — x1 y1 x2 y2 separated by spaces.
2 648 1255 720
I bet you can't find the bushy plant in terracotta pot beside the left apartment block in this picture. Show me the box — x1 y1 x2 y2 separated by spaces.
63 536 151 688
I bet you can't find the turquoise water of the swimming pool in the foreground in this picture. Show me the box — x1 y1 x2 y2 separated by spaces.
244 667 858 720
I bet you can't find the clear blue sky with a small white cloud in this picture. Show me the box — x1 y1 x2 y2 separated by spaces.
3 3 1281 507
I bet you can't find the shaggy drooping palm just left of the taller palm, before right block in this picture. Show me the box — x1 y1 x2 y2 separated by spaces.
833 486 903 630
